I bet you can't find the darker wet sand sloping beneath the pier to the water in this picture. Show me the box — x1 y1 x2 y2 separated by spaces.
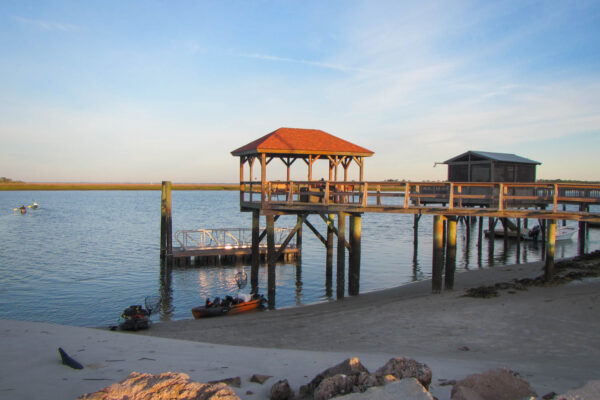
138 263 600 395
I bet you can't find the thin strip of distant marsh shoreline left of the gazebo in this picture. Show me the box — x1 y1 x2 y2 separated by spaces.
0 182 240 191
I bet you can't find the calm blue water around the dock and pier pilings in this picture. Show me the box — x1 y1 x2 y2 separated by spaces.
0 191 600 326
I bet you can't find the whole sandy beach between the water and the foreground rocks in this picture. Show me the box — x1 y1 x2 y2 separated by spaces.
0 259 600 399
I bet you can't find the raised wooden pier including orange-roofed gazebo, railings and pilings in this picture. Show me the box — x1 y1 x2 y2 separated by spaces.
161 128 600 308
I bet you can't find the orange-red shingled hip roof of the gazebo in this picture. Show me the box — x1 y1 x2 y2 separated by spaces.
231 128 373 157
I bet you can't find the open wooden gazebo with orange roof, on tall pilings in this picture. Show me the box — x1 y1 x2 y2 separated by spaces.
231 128 373 307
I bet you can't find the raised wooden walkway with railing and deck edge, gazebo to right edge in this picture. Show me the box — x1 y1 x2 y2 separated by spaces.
240 181 600 222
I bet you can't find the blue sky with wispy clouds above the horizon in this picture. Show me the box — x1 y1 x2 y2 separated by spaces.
0 0 600 182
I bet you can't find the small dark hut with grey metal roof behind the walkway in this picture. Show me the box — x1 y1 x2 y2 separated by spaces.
442 150 541 182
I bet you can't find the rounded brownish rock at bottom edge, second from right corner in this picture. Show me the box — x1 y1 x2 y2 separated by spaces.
451 369 537 400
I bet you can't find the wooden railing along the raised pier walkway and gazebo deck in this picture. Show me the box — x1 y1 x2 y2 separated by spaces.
240 181 600 211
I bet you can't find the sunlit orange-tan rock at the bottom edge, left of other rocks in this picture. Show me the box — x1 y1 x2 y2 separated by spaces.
78 372 240 400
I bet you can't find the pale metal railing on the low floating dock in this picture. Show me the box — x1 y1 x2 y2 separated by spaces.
175 228 293 250
